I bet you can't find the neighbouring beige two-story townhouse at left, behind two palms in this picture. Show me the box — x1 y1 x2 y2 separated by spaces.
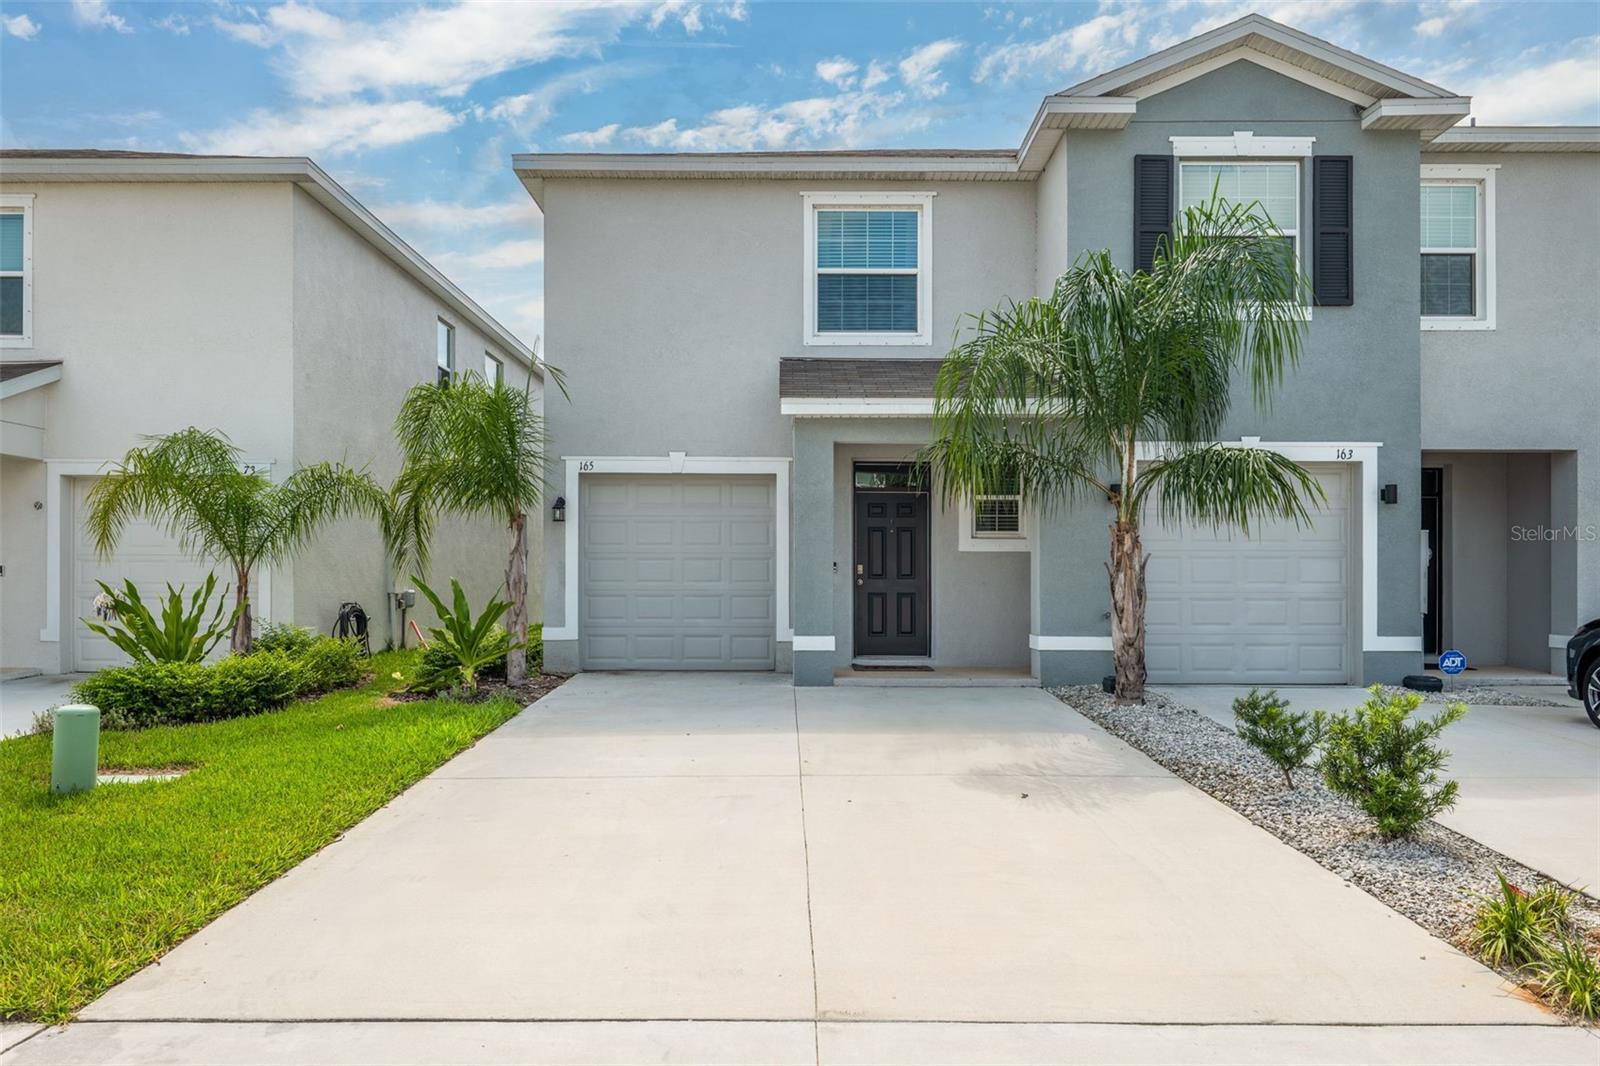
0 150 542 672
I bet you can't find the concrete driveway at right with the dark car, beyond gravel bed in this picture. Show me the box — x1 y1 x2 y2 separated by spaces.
1157 685 1600 890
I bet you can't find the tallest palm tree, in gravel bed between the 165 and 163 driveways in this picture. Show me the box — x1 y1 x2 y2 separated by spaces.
925 200 1325 701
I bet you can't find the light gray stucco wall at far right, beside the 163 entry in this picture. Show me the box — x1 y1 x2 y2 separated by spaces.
1421 152 1600 646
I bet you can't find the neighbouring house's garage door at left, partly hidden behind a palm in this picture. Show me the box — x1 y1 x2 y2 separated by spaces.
72 477 234 671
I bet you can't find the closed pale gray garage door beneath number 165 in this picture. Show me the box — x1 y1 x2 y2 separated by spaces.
579 474 778 671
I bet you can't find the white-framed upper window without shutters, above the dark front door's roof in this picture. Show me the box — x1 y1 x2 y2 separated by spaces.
805 192 933 344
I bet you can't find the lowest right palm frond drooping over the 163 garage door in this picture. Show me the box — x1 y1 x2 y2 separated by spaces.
1128 443 1328 536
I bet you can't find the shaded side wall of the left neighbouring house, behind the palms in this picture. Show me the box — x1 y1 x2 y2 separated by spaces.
293 184 542 647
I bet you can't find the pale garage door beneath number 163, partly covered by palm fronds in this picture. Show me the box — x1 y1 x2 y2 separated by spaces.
1144 466 1354 685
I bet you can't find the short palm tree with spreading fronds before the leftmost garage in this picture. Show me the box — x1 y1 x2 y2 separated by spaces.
86 426 387 655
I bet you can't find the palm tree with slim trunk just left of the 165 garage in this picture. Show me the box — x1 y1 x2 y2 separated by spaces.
389 368 562 685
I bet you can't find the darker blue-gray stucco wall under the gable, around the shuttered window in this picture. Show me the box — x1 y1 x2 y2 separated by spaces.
1040 62 1421 680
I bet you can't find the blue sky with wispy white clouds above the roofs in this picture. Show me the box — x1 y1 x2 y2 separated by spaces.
0 0 1600 344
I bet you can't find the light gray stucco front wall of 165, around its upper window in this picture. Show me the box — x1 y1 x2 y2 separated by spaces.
544 179 1035 671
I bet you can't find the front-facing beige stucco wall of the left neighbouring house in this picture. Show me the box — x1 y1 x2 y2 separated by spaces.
0 181 294 669
